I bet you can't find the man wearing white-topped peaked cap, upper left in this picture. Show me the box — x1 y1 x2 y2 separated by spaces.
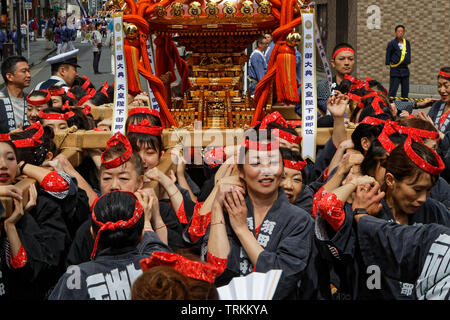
34 49 81 91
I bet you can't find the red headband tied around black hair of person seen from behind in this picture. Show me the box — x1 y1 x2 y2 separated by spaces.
91 191 144 260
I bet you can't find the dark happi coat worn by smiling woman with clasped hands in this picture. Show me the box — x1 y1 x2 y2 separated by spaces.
209 188 313 299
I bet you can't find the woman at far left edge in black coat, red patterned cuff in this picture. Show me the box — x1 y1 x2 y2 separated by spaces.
0 130 72 300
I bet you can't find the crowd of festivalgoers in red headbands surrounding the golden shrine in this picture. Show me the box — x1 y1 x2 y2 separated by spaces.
0 23 450 300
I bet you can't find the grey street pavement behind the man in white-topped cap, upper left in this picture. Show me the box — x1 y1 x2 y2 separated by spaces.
0 38 114 93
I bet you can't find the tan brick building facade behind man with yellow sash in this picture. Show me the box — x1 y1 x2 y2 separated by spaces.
315 0 450 86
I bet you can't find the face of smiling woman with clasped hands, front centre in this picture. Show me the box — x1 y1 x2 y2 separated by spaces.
239 150 283 195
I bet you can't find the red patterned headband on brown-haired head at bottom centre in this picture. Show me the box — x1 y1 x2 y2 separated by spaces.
139 251 219 283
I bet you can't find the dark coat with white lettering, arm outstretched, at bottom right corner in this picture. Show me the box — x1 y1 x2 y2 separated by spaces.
357 216 450 300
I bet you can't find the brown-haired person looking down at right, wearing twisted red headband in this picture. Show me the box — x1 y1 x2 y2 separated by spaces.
315 134 450 299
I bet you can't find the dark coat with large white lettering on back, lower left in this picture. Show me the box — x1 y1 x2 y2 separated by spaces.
49 231 170 300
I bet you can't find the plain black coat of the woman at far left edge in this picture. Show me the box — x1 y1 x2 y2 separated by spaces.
0 190 69 300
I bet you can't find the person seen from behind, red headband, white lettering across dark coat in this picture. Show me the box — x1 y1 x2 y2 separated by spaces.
49 191 170 300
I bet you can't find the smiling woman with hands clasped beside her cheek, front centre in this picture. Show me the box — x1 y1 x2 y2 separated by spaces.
207 131 313 299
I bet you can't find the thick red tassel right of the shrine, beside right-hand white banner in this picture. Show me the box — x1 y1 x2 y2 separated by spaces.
275 45 300 104
